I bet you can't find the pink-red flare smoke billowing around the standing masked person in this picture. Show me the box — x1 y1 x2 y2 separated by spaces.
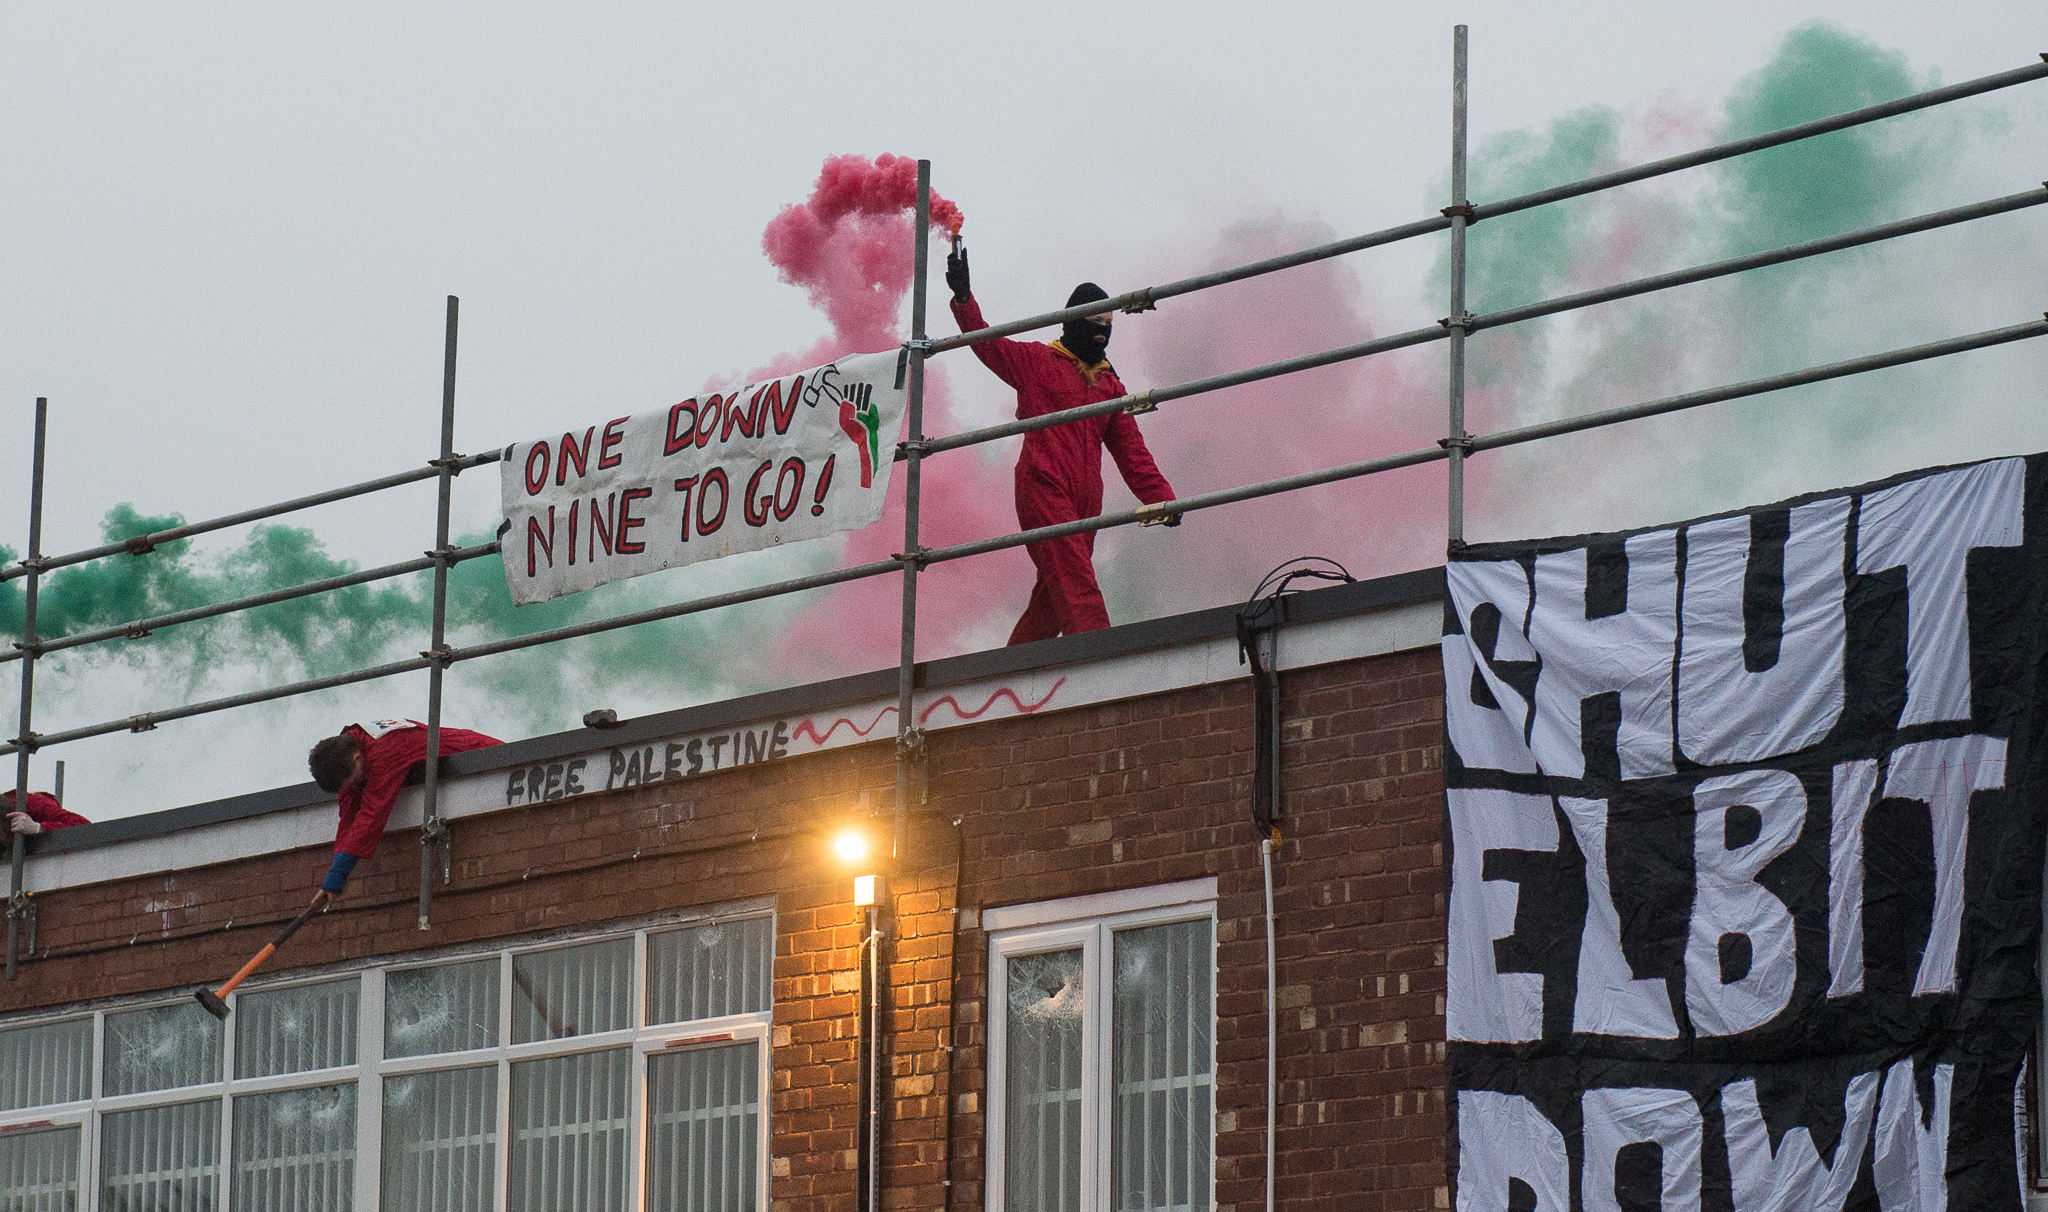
750 135 1720 676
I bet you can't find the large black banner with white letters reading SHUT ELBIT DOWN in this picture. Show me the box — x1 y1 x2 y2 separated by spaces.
1444 455 2048 1212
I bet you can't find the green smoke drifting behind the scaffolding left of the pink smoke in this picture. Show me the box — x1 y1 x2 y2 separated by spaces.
0 504 811 731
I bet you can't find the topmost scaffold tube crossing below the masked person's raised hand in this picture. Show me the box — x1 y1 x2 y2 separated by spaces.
928 55 2048 354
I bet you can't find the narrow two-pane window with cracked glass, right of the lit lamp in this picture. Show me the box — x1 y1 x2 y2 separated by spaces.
981 880 1217 1212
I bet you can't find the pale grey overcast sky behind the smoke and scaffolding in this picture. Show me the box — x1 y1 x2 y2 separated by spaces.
0 0 2048 817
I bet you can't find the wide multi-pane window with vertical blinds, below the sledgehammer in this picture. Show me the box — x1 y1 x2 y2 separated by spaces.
0 911 774 1212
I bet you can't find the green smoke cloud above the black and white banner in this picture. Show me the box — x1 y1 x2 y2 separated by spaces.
1432 23 2038 536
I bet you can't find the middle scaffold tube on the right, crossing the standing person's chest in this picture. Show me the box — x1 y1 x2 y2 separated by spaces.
921 186 2048 459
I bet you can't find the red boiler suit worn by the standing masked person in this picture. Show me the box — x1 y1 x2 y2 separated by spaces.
952 299 1174 645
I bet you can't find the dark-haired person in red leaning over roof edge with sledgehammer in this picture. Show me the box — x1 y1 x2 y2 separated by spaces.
305 721 504 903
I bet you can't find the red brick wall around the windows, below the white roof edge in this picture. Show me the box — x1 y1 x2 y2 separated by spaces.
0 651 1446 1212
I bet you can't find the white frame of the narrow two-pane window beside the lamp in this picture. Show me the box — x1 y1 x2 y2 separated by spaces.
981 876 1217 1212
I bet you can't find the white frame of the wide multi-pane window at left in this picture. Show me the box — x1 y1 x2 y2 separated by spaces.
0 901 776 1212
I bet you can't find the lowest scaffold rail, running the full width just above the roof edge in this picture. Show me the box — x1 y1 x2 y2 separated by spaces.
0 315 2048 755
